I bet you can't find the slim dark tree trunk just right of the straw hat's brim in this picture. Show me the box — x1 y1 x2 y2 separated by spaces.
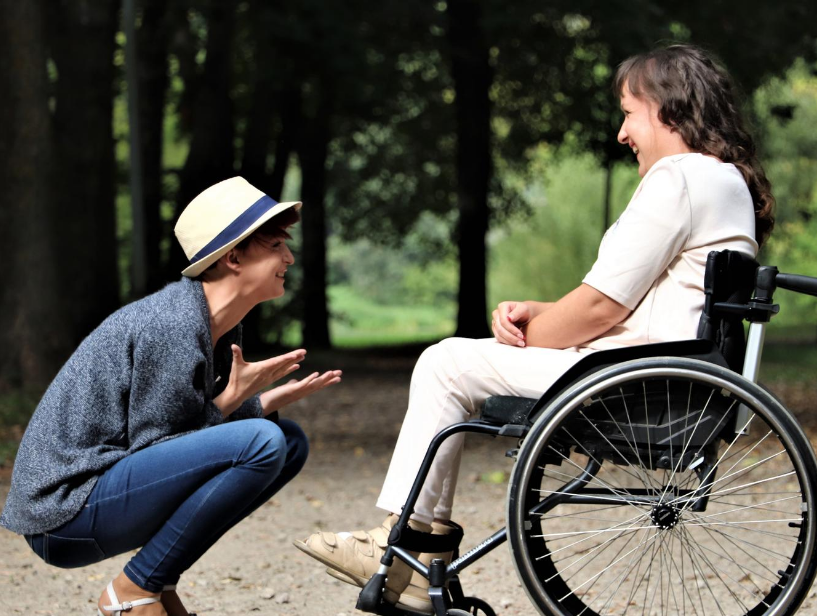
298 91 331 349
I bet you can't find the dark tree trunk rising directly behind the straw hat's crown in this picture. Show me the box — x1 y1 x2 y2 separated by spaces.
166 2 235 280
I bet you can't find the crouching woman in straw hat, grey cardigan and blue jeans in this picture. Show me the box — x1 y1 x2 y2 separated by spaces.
0 177 341 616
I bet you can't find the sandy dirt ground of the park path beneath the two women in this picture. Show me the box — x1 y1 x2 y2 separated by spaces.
0 346 817 616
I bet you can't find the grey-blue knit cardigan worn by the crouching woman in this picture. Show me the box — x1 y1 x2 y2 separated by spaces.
0 278 262 534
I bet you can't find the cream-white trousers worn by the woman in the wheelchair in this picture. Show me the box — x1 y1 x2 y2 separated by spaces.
377 338 584 524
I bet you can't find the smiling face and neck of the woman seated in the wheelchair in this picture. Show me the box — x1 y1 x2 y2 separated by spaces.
618 84 692 178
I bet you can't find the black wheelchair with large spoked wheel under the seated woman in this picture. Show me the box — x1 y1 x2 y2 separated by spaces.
357 251 817 616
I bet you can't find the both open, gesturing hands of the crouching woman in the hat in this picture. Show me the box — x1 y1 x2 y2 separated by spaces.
213 344 342 417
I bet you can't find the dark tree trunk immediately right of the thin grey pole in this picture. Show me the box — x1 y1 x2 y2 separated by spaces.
136 0 169 293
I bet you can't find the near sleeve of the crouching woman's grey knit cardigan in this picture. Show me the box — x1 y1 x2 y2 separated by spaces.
128 317 222 450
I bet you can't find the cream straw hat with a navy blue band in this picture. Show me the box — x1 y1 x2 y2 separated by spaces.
173 177 301 278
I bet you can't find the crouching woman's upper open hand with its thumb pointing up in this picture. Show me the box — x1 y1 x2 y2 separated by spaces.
213 344 306 417
